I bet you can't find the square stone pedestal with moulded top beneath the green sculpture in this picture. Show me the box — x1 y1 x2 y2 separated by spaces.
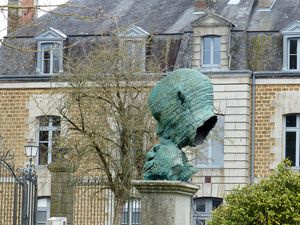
132 180 199 225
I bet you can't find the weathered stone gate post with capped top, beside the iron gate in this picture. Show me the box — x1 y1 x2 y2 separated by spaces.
48 159 75 225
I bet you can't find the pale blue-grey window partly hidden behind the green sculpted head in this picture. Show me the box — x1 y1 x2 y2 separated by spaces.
195 115 224 168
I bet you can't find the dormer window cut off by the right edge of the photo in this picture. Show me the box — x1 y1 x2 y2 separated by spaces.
280 21 300 71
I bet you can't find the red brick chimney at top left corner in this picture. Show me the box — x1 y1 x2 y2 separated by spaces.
7 0 35 33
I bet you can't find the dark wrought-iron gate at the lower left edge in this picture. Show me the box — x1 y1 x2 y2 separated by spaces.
0 152 37 225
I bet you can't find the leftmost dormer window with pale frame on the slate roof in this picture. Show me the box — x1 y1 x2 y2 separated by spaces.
35 27 67 75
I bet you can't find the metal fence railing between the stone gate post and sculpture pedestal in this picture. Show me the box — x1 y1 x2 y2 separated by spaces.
73 177 141 225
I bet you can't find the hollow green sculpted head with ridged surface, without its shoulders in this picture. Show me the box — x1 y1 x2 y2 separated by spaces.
148 69 217 148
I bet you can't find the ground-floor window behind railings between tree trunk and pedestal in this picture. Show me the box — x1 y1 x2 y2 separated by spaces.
121 199 141 225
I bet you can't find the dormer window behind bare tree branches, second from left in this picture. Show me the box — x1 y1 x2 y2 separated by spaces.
119 25 149 71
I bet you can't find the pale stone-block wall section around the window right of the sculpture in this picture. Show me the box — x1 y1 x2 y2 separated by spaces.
193 72 250 198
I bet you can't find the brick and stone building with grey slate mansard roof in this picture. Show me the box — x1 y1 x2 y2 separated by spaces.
0 0 300 222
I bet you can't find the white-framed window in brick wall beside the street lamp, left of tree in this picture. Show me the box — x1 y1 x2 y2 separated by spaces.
38 116 61 165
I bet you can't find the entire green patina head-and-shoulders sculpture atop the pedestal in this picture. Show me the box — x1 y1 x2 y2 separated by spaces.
144 69 217 181
